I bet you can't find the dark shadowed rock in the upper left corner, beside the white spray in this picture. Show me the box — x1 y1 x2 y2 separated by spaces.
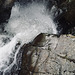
0 0 15 32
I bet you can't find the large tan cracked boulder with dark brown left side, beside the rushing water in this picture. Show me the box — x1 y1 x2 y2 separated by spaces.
19 34 75 75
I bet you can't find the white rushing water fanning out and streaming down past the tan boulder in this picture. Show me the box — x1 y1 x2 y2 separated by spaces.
0 3 57 75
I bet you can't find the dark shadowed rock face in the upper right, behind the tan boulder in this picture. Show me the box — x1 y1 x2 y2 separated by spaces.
54 0 75 33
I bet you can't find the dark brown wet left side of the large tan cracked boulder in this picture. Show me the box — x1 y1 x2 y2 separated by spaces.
19 45 35 75
